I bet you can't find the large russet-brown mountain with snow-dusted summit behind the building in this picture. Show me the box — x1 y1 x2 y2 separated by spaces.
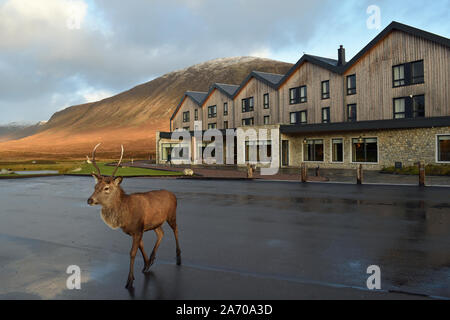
0 57 292 159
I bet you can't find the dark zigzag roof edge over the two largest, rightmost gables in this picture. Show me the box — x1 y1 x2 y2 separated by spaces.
278 21 450 88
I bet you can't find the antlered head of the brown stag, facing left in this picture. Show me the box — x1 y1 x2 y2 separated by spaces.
87 143 124 207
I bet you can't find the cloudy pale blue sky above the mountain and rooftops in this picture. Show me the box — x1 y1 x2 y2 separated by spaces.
0 0 450 124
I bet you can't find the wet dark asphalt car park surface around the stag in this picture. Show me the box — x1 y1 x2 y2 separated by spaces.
0 177 450 299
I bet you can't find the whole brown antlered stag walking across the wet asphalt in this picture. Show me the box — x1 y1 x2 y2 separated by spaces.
87 144 181 288
